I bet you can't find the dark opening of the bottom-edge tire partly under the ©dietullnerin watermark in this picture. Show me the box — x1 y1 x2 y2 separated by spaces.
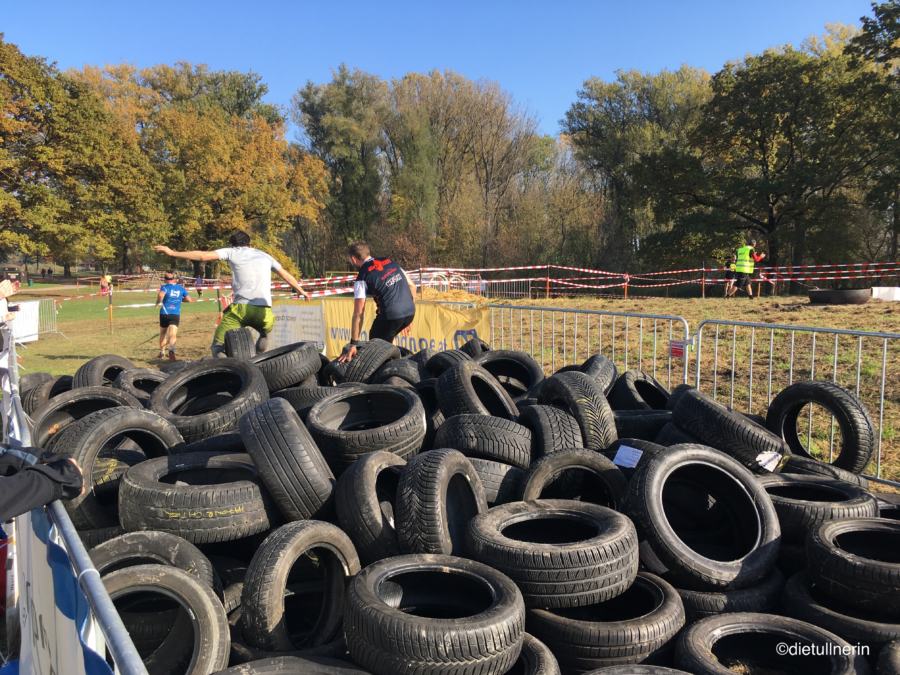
711 632 832 675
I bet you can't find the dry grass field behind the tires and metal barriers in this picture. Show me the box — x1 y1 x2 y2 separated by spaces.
12 287 900 486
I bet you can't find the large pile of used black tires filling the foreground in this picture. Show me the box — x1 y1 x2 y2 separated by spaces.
22 335 900 675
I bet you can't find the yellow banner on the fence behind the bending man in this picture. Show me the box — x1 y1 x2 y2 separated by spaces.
322 298 490 358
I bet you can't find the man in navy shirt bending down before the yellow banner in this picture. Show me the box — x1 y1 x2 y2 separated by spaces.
339 241 416 363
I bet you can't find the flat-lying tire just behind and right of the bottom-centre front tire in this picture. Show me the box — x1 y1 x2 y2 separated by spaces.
466 499 638 608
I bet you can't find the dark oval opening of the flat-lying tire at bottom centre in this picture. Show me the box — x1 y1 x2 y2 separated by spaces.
375 570 494 619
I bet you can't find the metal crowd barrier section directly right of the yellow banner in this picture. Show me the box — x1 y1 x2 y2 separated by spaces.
488 305 691 387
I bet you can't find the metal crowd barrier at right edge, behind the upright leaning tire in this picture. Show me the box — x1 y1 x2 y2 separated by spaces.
695 319 900 487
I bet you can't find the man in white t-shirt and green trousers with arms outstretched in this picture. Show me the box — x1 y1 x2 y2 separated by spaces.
153 230 310 356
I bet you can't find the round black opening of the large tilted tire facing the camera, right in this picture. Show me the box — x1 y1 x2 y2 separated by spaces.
662 464 762 562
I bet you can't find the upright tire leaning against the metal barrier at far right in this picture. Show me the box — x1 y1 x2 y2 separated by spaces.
766 381 876 474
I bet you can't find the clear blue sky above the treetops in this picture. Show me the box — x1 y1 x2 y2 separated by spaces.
0 0 871 134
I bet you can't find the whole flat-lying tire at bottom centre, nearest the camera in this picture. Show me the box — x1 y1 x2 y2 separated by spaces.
344 555 525 675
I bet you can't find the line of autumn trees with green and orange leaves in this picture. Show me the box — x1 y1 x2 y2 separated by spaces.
0 0 900 275
